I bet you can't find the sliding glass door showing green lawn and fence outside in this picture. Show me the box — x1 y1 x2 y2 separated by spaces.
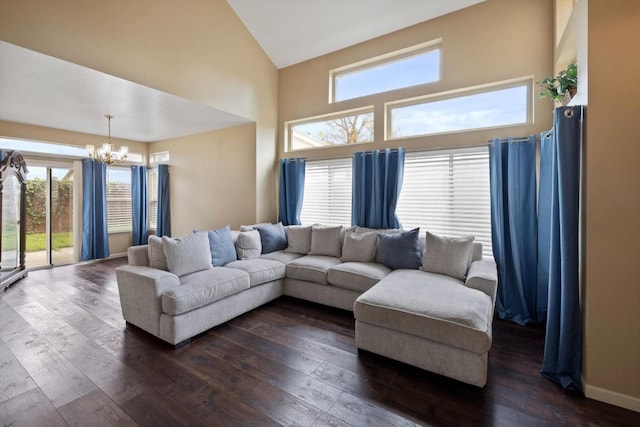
25 162 74 268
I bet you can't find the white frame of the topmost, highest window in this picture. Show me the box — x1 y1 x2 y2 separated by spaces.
329 37 442 104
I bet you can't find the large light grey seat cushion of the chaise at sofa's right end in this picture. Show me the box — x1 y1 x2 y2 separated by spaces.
354 270 493 353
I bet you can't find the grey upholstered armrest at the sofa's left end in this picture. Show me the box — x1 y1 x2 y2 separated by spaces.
116 265 180 336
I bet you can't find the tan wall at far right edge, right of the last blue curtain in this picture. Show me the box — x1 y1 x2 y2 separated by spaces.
584 0 640 411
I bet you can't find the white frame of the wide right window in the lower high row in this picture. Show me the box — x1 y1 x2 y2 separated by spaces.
384 76 534 141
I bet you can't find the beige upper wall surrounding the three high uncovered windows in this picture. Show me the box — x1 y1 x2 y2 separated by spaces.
278 0 553 159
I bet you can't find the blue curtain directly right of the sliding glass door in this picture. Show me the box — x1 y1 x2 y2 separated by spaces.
80 159 109 261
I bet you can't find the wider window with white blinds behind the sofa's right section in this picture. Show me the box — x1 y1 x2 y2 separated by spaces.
396 148 493 257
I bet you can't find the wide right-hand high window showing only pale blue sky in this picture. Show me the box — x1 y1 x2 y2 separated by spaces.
385 80 532 139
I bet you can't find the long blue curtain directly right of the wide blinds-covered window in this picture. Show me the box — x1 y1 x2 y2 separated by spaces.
489 135 546 325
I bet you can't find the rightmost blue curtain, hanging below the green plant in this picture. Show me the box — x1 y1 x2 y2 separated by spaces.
538 106 582 390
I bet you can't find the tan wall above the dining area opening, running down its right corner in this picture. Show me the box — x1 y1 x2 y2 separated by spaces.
0 0 278 228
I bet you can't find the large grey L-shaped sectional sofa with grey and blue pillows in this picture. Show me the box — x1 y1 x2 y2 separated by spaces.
116 224 497 387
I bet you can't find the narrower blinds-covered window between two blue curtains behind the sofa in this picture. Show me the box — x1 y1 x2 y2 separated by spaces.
300 158 351 225
